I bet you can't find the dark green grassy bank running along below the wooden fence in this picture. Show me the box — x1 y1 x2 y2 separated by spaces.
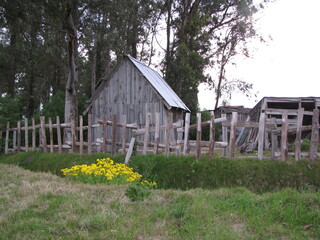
0 152 320 193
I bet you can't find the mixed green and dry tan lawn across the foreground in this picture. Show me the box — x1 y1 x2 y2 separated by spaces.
0 164 320 240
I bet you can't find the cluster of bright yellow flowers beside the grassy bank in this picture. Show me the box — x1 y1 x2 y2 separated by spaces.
61 158 142 183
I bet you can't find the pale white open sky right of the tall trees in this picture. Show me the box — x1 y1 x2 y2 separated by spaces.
198 0 320 110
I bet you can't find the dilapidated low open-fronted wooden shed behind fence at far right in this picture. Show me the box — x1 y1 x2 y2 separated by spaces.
238 97 320 151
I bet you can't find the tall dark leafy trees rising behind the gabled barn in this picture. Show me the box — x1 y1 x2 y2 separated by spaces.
0 0 268 124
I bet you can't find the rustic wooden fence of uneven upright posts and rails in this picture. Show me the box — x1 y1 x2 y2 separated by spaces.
0 110 319 162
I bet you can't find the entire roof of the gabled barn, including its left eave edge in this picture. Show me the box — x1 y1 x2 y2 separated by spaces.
83 55 190 114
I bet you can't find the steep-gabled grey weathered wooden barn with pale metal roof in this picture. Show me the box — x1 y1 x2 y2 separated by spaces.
84 55 190 144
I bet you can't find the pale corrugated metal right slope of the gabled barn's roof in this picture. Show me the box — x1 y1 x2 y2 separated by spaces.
127 55 190 112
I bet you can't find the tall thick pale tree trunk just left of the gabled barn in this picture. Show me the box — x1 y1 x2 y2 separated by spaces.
64 0 78 142
